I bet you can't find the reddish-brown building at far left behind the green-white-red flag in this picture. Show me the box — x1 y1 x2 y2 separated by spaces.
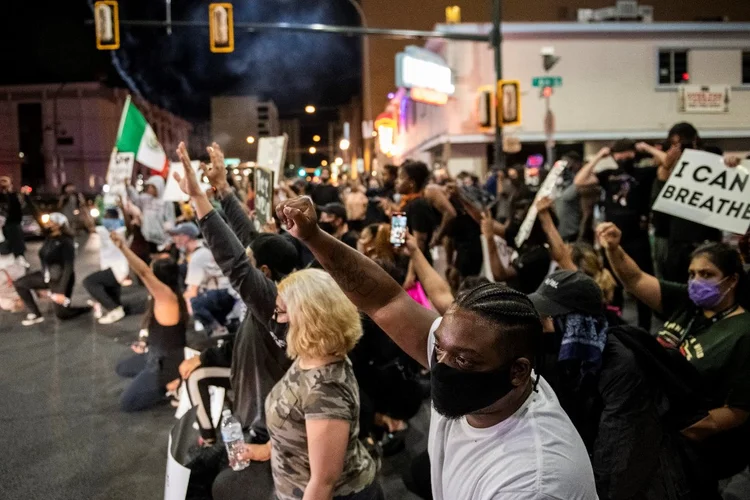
0 82 191 192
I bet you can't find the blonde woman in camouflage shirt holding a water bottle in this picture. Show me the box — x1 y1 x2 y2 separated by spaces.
247 269 383 500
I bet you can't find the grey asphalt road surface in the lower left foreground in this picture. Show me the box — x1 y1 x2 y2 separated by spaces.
0 236 428 500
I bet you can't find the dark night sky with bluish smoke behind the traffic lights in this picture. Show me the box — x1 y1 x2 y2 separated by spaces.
0 0 360 121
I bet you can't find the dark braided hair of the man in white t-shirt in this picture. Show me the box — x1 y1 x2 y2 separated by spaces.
454 283 542 366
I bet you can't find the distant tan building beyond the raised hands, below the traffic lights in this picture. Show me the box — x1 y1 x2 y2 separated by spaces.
211 96 281 161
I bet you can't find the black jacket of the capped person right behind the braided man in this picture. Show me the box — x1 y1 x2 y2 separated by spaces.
545 326 707 500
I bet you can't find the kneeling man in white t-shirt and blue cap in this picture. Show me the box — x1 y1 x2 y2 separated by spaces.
169 222 236 336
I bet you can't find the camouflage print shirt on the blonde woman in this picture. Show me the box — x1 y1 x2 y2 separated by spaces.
266 358 376 500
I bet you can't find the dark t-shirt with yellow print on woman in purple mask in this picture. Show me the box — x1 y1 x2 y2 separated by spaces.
657 281 750 411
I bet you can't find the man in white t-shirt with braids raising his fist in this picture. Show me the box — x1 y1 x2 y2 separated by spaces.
277 197 597 500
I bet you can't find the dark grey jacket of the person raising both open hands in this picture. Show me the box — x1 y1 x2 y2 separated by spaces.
200 191 292 438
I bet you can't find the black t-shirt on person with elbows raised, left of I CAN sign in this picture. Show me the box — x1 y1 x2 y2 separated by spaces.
596 167 657 237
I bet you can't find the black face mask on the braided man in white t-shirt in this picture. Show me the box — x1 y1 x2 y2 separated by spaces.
430 353 515 420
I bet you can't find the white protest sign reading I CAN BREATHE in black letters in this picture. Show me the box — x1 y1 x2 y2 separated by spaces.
653 149 750 234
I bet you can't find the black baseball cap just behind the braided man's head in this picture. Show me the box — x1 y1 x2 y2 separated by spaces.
529 270 604 317
